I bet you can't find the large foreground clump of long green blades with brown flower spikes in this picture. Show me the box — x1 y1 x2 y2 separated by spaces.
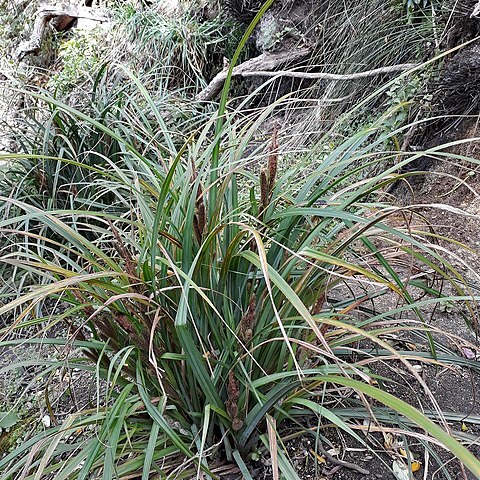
0 1 480 480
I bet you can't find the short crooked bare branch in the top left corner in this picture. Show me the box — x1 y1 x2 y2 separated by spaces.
14 5 108 61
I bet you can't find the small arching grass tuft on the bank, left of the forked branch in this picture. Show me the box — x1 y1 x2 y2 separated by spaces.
113 4 242 91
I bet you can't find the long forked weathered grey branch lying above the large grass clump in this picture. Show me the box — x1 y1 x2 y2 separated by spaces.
197 54 418 101
